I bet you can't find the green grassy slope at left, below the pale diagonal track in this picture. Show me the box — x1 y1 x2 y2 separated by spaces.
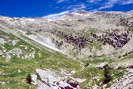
0 31 80 89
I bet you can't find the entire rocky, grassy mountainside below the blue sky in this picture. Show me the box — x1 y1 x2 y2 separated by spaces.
0 11 133 89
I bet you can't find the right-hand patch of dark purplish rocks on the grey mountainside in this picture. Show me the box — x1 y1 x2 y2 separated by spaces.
93 30 130 48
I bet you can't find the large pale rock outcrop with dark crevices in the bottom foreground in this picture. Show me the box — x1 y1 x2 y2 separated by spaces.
27 69 83 89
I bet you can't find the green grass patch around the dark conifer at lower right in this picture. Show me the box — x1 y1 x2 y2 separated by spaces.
74 66 125 89
